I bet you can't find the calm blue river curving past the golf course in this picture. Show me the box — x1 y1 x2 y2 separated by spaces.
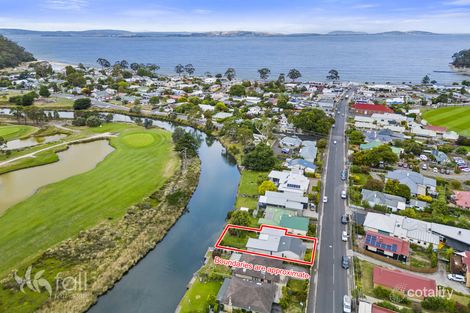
0 109 240 313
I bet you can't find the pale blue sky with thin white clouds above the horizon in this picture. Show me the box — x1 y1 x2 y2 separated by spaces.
0 0 470 33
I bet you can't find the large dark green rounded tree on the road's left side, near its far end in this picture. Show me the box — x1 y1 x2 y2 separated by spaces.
292 108 334 134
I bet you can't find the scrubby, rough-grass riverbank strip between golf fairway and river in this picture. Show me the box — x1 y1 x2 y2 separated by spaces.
0 135 200 312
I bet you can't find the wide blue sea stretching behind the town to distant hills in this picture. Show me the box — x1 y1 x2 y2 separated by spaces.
4 35 470 83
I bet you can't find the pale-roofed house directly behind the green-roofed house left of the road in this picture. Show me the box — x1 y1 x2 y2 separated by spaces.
258 191 309 216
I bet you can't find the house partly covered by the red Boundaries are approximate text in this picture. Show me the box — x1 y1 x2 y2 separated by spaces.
232 253 284 284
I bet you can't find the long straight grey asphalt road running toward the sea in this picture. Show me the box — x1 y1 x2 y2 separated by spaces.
308 91 352 313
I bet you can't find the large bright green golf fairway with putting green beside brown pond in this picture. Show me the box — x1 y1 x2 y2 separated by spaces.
0 125 179 275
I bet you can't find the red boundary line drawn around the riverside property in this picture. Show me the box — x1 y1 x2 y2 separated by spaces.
215 224 318 266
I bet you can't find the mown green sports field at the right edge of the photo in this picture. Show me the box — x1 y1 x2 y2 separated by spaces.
423 106 470 136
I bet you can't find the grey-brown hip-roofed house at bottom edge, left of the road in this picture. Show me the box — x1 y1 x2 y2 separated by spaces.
216 277 277 313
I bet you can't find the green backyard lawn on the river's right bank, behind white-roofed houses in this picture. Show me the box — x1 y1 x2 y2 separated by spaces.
235 170 268 209
